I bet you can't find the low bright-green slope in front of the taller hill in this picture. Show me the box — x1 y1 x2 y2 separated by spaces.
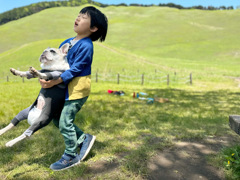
0 39 158 74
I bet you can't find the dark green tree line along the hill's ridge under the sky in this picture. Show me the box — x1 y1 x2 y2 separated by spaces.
0 0 234 25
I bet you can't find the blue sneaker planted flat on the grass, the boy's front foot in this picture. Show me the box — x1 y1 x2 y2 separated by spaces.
50 153 80 171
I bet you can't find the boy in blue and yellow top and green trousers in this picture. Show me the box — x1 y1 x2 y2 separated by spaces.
40 6 108 171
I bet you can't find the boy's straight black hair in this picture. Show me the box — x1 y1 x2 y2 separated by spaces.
80 6 108 42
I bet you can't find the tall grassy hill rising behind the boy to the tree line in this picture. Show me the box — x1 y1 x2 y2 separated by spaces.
0 6 240 82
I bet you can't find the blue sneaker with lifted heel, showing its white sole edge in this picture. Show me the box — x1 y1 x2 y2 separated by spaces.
79 134 96 161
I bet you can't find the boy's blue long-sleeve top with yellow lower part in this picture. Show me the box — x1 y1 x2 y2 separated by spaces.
60 37 93 100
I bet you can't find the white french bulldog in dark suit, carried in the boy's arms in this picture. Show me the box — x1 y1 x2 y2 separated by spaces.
0 43 69 147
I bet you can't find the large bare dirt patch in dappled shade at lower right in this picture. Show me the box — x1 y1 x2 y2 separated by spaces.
148 136 240 180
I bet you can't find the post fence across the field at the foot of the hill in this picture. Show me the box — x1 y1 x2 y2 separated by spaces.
0 72 192 85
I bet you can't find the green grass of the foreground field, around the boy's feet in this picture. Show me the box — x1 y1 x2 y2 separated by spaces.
0 81 240 179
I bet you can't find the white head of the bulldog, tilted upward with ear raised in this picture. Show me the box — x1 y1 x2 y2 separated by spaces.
39 43 69 70
